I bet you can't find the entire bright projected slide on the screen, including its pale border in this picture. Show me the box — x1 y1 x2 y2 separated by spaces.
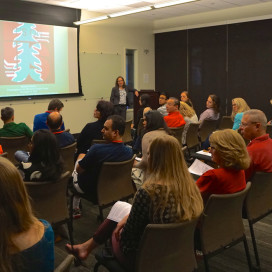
0 21 79 98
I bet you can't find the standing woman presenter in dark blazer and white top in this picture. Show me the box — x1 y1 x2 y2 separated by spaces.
110 76 139 120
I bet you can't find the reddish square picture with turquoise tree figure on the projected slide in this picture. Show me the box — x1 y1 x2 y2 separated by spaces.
3 22 54 85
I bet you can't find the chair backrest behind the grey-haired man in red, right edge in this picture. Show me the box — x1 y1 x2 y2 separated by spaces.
244 172 272 221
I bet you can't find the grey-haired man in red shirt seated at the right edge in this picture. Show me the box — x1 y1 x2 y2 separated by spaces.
240 110 272 180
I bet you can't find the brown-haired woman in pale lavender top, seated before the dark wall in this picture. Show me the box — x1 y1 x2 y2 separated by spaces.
199 94 220 127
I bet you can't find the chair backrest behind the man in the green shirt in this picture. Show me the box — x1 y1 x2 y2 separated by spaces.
0 136 29 164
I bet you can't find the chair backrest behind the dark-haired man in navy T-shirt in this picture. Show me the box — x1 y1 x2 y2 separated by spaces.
97 155 135 206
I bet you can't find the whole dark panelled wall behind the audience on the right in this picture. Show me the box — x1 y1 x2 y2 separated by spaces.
155 20 272 119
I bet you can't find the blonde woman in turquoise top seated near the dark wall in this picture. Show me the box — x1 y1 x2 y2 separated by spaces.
231 97 250 130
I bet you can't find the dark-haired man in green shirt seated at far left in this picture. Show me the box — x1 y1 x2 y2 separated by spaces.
0 107 33 138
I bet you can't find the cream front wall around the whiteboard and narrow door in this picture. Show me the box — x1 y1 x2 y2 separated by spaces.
0 15 155 133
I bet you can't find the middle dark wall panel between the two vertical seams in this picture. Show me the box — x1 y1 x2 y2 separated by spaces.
188 26 227 115
